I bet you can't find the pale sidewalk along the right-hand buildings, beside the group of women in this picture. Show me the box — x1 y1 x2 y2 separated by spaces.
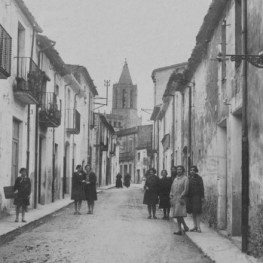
174 217 262 263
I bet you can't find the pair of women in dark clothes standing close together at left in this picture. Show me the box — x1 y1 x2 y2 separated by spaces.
71 164 97 215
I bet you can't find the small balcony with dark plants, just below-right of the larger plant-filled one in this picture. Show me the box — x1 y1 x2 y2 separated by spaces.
39 92 61 128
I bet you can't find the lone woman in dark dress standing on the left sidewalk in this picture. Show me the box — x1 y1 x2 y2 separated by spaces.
14 168 31 222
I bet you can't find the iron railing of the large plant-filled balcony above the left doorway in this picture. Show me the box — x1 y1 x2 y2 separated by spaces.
15 57 44 101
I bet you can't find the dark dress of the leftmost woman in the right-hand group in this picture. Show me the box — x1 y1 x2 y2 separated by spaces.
143 175 160 205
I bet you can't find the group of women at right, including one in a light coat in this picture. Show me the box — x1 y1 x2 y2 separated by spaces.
143 165 204 235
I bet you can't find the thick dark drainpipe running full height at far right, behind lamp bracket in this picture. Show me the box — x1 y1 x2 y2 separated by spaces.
241 0 249 253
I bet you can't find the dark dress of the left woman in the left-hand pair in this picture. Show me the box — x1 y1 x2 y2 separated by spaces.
71 172 86 201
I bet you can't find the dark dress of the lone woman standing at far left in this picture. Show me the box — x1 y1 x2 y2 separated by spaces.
14 176 31 206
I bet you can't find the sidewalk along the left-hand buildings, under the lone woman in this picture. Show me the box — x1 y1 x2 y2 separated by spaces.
0 185 115 245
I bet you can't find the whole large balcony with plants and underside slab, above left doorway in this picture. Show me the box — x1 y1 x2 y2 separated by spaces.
14 57 44 104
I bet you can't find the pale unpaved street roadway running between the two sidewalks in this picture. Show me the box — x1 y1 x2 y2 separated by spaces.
0 186 210 263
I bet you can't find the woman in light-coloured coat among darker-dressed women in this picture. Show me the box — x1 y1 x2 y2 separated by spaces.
170 165 189 235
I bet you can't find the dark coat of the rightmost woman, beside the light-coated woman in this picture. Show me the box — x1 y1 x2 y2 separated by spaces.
187 174 204 214
